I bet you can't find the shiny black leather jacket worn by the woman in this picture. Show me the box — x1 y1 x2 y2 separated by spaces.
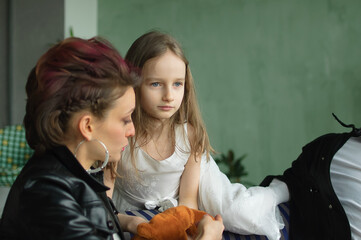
0 147 124 240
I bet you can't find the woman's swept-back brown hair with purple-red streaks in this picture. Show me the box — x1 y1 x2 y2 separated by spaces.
24 38 140 153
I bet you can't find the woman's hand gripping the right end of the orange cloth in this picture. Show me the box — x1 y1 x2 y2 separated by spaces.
196 214 224 240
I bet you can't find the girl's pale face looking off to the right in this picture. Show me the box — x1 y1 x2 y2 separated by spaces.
140 50 186 120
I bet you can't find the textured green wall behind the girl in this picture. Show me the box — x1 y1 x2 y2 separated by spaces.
98 0 361 183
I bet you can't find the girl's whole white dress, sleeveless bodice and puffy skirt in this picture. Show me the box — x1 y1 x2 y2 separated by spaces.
113 124 288 240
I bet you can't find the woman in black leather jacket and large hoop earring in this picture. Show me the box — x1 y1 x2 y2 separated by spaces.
0 38 221 239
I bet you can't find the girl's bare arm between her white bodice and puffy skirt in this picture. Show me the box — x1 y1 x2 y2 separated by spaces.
179 124 202 209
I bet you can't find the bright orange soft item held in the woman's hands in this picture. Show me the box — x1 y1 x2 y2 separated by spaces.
132 206 211 240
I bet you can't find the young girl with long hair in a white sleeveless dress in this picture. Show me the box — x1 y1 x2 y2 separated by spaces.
113 31 283 239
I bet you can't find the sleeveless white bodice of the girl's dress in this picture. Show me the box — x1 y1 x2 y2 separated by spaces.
113 124 190 211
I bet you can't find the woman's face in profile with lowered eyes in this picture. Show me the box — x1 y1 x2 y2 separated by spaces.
92 87 135 162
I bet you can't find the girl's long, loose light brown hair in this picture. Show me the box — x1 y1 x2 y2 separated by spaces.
125 31 214 164
